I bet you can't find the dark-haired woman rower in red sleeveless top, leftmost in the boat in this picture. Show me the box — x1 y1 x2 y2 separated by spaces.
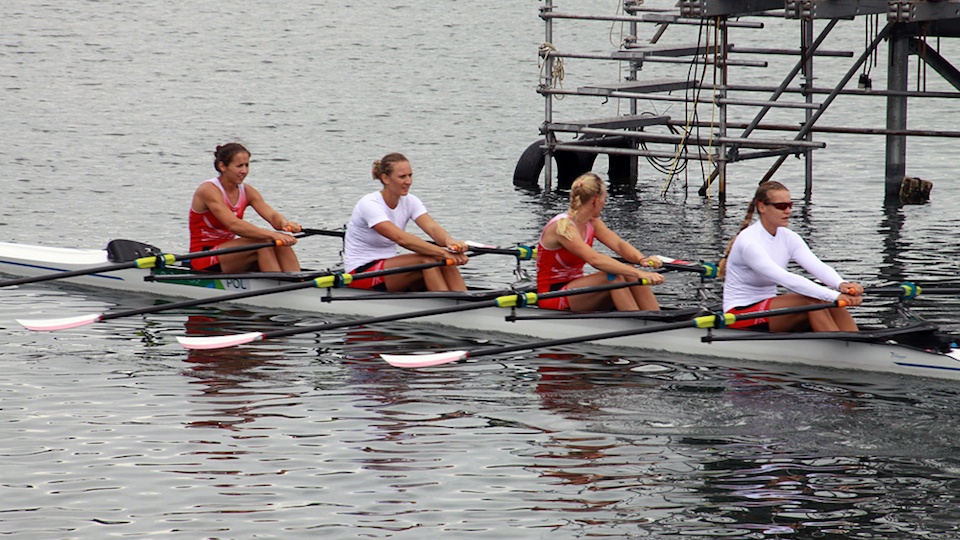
190 143 301 272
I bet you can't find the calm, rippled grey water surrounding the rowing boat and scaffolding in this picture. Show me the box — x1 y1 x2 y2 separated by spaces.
0 0 960 539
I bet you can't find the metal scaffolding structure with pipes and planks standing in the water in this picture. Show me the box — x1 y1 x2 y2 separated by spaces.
514 0 960 203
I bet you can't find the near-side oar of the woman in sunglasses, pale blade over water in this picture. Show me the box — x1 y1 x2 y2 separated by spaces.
380 300 846 368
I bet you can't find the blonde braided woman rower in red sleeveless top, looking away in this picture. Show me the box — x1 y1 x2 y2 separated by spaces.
537 172 663 311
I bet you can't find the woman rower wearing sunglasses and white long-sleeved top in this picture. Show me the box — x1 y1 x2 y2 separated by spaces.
720 181 863 332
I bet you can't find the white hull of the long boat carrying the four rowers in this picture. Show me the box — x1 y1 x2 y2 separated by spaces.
0 242 960 379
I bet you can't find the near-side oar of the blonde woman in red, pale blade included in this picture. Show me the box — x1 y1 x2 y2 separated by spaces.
177 281 646 349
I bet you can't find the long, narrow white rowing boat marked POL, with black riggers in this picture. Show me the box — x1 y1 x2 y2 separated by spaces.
0 242 960 379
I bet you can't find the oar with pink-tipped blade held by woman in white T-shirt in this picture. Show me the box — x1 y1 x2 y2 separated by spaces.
17 258 454 332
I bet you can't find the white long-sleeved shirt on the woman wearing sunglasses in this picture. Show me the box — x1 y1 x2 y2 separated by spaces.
723 220 844 311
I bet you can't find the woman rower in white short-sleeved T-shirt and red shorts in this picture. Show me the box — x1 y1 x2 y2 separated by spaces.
344 153 467 291
